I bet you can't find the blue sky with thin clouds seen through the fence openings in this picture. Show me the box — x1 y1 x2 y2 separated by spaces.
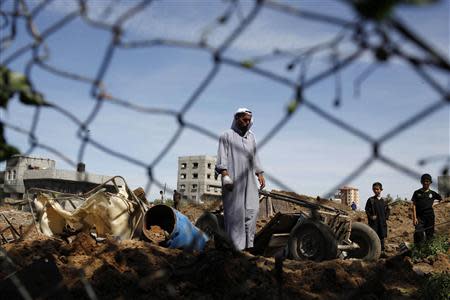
0 0 450 205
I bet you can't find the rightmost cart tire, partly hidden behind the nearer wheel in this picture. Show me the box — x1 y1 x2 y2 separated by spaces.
348 222 381 260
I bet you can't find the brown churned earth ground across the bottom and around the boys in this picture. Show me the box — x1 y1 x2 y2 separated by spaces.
0 193 450 299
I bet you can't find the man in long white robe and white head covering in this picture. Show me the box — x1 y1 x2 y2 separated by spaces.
216 108 265 250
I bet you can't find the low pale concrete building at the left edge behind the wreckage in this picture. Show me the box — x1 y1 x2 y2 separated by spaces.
0 155 111 199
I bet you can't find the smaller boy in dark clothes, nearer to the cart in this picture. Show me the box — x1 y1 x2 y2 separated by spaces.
365 182 390 256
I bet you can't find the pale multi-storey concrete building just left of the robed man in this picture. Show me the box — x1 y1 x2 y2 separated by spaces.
177 155 222 203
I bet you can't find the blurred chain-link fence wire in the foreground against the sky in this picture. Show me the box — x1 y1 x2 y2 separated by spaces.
1 1 449 195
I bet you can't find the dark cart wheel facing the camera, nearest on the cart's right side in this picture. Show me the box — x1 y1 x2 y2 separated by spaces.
288 220 337 261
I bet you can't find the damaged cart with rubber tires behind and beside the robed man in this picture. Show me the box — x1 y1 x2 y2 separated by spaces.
196 191 381 261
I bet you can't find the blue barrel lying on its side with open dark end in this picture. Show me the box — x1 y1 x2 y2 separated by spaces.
143 204 208 252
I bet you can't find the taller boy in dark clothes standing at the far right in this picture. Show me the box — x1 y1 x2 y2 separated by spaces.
411 174 442 243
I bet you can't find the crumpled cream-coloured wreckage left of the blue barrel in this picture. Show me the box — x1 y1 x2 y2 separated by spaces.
29 176 148 239
